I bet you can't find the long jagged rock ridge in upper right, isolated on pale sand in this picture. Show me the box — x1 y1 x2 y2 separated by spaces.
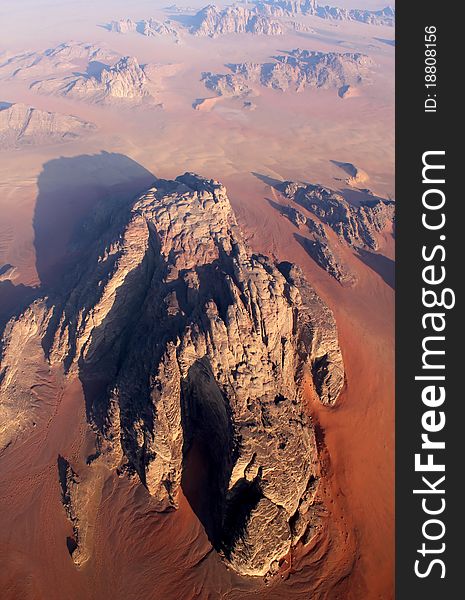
202 49 374 96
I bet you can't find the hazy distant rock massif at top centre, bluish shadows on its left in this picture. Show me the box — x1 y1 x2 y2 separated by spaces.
191 4 284 37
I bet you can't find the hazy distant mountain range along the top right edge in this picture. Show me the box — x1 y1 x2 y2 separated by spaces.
256 0 396 27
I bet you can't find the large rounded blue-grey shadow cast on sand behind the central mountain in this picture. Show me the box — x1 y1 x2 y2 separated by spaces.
33 152 156 293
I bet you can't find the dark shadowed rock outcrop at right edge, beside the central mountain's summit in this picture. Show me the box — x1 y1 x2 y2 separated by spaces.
278 181 395 250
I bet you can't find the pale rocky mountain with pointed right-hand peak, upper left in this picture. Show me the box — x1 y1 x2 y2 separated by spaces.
31 56 160 103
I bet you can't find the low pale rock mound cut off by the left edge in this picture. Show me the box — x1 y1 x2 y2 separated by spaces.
0 102 95 149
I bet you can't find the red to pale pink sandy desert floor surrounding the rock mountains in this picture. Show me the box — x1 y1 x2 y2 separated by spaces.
0 0 394 600
